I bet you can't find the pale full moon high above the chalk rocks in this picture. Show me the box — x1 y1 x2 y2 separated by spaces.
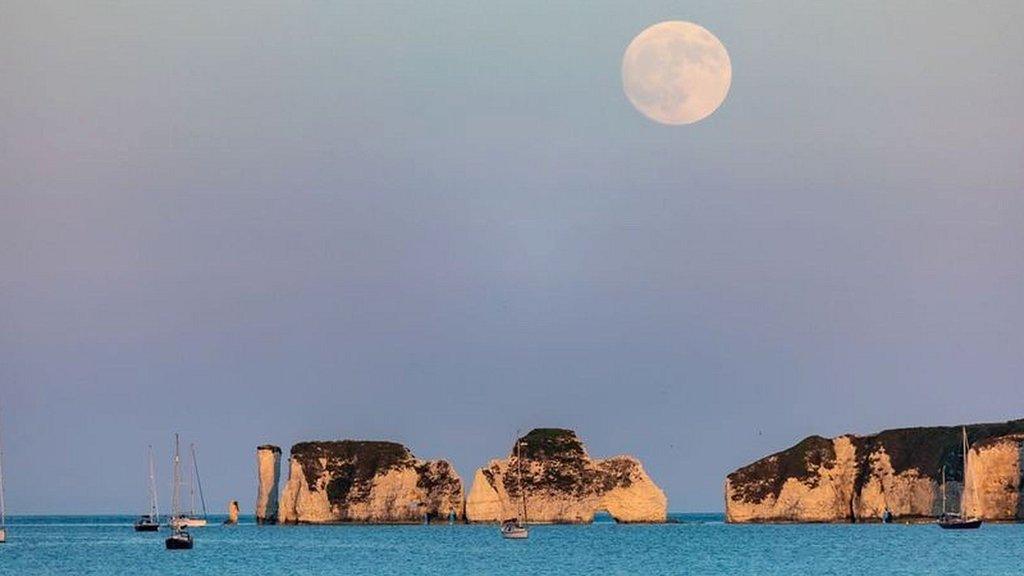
623 20 732 125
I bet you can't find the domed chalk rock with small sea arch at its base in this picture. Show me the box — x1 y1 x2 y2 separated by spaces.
466 428 668 523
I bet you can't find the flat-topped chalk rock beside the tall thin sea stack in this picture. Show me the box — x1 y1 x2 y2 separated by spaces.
279 440 463 524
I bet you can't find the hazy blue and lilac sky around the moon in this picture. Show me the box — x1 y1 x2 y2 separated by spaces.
0 0 1024 513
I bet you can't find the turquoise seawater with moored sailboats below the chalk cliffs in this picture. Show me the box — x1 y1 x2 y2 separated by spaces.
0 515 1024 576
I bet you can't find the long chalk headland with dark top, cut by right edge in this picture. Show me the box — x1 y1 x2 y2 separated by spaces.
725 420 1024 522
